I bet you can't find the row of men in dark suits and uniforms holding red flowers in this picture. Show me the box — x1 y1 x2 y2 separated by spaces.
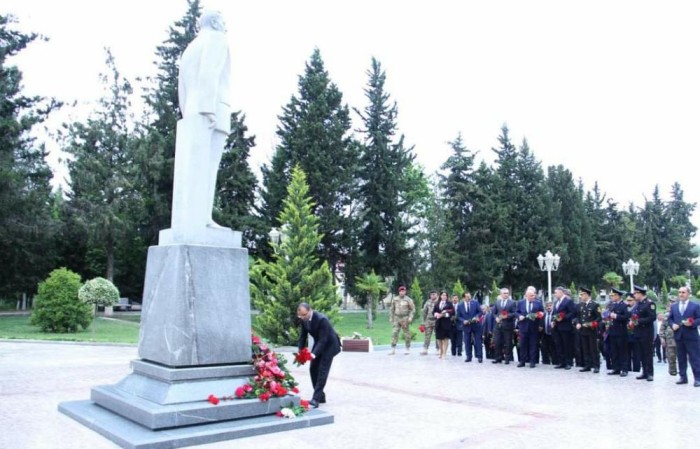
448 286 700 386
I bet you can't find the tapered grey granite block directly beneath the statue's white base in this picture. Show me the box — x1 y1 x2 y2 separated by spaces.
139 245 251 367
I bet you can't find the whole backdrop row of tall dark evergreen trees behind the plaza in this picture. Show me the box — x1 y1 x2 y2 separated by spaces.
0 0 697 306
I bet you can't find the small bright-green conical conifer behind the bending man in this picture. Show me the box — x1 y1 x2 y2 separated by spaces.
250 167 339 345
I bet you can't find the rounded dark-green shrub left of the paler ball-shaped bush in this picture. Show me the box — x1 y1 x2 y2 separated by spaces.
31 268 92 332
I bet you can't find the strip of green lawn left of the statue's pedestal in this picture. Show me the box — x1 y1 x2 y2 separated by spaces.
0 316 139 343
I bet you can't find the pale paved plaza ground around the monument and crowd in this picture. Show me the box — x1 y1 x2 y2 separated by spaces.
0 341 700 449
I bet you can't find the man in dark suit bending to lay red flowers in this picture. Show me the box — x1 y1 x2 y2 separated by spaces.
297 302 340 408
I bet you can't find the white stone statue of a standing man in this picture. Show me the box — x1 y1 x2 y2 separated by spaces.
173 11 231 227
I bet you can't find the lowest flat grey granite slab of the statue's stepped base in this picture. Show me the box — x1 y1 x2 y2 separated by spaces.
58 401 333 449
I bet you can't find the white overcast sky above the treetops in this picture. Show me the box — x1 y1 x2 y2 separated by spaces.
5 0 700 233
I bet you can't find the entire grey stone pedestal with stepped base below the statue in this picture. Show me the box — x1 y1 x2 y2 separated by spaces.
59 245 333 449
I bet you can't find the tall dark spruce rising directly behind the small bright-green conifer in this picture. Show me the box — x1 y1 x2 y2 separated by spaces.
261 49 357 267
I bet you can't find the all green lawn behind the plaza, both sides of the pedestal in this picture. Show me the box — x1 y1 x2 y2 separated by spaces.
0 311 421 345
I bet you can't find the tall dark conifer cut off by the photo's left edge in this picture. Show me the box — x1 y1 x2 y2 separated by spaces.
0 14 60 297
